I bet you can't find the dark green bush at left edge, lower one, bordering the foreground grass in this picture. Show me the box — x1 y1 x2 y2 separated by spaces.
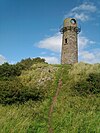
0 79 43 104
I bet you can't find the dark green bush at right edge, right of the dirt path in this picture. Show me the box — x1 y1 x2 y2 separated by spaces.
74 73 100 94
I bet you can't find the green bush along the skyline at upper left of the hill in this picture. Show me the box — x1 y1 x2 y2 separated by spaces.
0 57 46 80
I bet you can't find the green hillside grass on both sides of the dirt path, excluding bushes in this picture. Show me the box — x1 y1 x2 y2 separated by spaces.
0 63 100 133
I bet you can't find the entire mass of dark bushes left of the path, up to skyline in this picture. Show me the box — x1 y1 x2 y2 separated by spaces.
0 58 47 105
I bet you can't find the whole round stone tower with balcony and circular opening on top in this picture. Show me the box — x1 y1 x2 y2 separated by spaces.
60 18 80 64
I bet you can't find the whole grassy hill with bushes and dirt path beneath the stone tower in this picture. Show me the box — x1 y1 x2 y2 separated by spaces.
0 63 100 133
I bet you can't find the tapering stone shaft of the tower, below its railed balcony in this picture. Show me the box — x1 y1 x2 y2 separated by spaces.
61 19 78 64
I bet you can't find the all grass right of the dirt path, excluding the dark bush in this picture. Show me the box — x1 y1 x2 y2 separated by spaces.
52 63 100 133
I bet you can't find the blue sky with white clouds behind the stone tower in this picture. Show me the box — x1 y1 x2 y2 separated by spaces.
0 0 100 64
